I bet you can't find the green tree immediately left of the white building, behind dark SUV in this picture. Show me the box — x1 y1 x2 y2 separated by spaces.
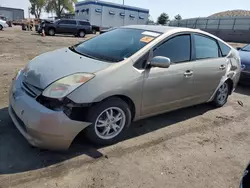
46 0 77 18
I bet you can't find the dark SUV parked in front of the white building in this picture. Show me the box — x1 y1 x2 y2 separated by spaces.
38 19 92 37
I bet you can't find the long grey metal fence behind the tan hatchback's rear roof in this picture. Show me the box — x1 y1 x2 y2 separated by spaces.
169 17 250 43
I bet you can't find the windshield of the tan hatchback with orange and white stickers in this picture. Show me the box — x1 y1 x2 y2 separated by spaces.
70 28 160 62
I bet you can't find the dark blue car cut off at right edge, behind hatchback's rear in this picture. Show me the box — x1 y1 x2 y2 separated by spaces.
237 44 250 84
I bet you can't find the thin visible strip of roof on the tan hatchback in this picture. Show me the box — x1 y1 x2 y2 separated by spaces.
124 25 200 33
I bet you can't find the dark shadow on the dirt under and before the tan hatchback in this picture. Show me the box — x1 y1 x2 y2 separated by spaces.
0 104 212 175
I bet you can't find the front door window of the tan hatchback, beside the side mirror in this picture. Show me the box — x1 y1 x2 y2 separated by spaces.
154 35 191 63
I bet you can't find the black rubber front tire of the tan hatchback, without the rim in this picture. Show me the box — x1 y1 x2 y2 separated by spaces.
85 98 132 145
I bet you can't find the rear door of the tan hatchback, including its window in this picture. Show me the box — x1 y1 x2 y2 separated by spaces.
192 34 229 102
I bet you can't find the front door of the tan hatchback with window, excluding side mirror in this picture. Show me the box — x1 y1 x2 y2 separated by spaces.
141 34 195 116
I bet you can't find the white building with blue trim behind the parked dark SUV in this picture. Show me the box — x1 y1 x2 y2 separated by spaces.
75 0 149 28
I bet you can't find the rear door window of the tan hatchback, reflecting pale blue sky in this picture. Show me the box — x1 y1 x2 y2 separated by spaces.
194 34 219 59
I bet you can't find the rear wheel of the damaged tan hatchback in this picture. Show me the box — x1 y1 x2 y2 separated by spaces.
212 82 230 107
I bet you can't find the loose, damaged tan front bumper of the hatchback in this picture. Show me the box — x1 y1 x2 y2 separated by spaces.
9 75 91 150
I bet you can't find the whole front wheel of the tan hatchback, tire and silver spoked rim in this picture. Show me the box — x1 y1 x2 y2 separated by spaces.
85 97 131 145
